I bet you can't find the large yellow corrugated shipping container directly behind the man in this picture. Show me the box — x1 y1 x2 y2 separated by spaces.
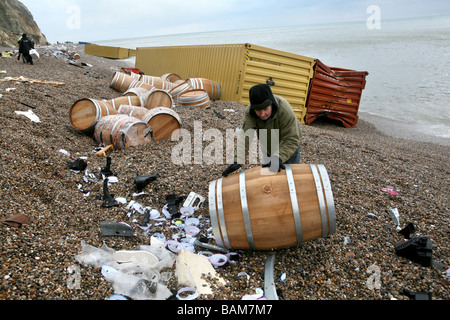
136 43 316 124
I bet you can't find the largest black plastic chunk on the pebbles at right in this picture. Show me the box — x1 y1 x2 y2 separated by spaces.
395 236 433 267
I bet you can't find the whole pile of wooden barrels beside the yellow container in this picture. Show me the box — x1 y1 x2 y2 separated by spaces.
69 72 221 150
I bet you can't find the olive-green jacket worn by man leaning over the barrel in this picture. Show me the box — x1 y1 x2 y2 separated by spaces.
235 95 302 164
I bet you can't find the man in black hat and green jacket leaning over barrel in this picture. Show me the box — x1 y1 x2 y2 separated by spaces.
222 84 302 177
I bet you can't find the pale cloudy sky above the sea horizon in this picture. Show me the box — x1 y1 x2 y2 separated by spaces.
20 0 450 43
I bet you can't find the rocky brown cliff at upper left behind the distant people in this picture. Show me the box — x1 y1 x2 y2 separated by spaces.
0 0 47 48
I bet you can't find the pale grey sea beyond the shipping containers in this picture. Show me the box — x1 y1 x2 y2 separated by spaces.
93 15 450 146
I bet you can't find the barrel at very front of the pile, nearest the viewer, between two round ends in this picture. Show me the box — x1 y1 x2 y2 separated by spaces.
94 114 152 150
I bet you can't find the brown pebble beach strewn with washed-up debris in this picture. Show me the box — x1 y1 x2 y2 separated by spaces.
0 44 450 301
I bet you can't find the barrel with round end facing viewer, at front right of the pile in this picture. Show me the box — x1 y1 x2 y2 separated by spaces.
142 107 182 141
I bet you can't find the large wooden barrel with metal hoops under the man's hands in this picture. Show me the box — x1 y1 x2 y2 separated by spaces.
209 164 336 250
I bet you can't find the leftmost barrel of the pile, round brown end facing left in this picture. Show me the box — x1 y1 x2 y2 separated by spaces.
69 99 117 134
